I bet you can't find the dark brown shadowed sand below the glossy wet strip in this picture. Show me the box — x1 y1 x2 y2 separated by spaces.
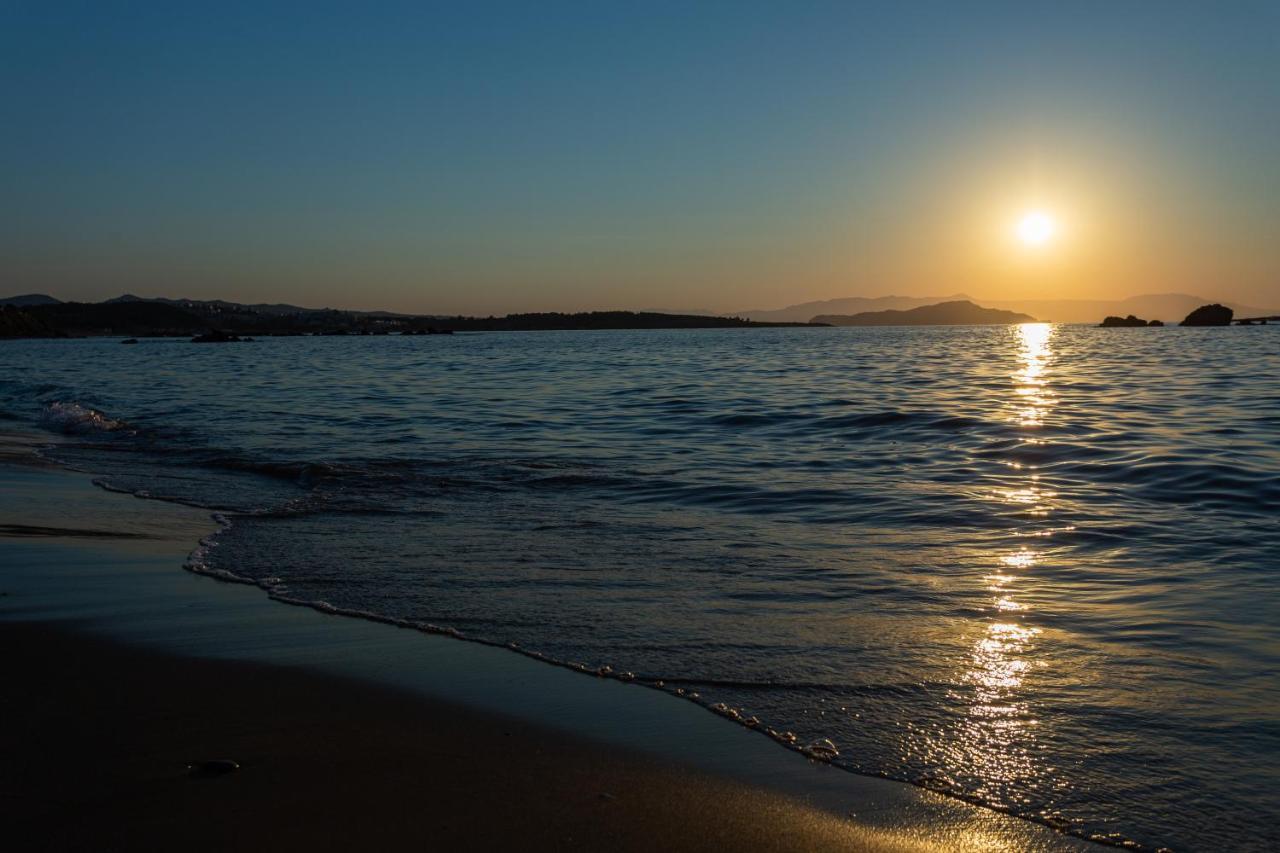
0 622 914 850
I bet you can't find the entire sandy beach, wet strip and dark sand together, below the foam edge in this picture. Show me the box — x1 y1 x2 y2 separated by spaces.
0 437 1093 849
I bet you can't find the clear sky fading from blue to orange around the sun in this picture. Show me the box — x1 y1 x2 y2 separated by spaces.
0 0 1280 314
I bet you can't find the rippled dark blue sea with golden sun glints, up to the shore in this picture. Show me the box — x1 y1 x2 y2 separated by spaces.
0 324 1280 850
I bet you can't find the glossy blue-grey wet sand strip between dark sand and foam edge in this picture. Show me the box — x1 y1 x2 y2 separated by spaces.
0 437 1097 849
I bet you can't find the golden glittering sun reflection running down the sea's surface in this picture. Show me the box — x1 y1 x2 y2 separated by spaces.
941 323 1055 807
